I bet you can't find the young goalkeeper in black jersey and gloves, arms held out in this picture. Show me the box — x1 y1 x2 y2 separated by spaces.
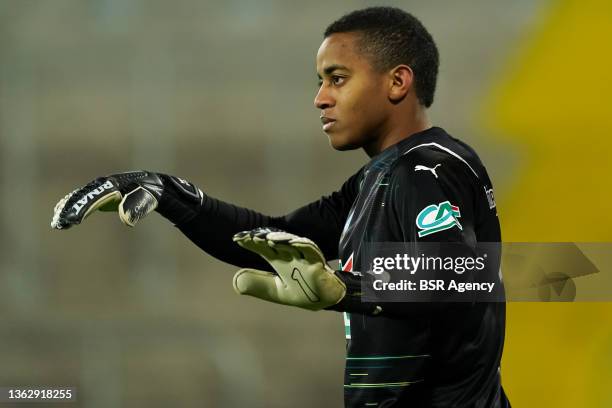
52 7 510 408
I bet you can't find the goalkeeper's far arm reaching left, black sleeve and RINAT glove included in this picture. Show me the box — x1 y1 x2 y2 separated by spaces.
51 167 359 270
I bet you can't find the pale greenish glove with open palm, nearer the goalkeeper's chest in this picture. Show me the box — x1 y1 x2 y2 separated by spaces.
234 228 346 310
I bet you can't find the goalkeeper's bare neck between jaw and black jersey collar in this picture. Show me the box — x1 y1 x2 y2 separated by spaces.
363 107 431 157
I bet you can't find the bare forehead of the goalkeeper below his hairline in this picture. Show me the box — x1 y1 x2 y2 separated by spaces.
317 33 369 74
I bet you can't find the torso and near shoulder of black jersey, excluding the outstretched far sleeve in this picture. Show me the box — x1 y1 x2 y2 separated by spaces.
339 128 507 407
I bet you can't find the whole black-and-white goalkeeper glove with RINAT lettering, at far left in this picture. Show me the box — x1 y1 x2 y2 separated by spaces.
51 171 204 229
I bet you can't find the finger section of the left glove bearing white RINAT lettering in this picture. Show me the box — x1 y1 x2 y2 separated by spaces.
51 177 121 229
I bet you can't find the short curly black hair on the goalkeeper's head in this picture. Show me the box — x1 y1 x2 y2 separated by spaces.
323 7 439 108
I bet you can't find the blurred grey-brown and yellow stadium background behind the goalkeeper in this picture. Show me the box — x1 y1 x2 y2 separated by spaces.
0 0 612 408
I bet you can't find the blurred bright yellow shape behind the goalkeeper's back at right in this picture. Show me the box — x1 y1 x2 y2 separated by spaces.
480 0 612 408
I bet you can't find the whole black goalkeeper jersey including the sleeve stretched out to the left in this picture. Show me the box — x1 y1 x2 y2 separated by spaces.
179 127 510 408
